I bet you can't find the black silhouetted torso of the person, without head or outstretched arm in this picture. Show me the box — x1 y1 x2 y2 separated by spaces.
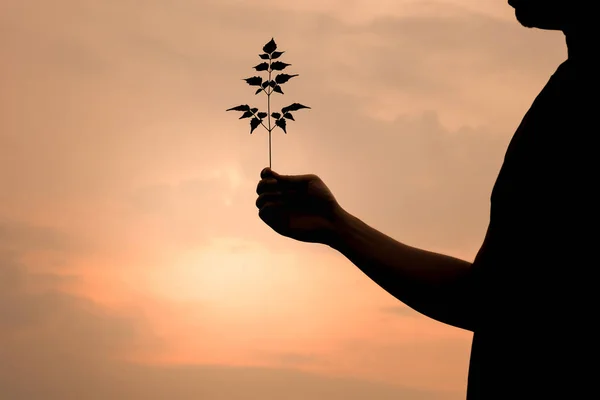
467 59 600 400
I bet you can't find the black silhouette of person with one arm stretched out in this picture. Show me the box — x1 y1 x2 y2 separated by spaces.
256 0 600 400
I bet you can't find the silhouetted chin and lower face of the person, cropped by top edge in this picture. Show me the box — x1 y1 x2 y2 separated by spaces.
508 0 595 31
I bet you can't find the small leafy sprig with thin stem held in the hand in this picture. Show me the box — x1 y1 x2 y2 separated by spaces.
225 38 310 168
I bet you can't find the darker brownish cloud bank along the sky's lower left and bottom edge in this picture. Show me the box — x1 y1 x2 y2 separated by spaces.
0 222 459 400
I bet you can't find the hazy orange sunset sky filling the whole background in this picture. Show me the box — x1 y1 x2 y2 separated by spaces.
0 0 566 400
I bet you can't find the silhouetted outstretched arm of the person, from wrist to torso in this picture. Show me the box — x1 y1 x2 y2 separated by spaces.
329 206 474 330
